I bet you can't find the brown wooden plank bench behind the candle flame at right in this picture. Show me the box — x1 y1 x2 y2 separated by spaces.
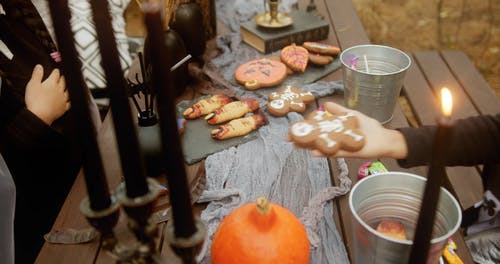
402 51 500 209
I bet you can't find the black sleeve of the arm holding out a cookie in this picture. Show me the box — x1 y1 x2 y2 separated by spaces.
398 114 500 167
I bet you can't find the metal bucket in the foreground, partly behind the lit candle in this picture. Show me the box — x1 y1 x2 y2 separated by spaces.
349 172 462 264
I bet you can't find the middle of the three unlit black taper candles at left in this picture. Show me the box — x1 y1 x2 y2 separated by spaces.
90 0 149 198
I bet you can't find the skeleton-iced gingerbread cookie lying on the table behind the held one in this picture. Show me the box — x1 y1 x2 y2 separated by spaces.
267 85 314 116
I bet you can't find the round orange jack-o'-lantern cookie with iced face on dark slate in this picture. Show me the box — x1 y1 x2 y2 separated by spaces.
234 58 286 90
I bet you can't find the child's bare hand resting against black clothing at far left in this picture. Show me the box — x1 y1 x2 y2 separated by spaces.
24 65 71 125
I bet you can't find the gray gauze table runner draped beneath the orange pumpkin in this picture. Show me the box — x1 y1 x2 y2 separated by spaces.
198 36 351 263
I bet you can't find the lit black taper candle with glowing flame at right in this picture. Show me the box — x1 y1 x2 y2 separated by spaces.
409 87 453 263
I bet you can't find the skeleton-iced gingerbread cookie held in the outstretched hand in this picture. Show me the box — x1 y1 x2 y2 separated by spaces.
290 110 365 155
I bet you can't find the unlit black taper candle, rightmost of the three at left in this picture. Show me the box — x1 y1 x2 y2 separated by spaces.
142 3 196 238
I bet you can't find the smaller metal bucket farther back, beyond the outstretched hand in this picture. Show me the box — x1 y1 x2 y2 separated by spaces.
340 45 411 124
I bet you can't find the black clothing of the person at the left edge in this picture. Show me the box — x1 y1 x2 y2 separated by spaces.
0 2 81 263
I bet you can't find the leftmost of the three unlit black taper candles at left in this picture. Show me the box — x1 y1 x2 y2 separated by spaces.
48 0 111 211
